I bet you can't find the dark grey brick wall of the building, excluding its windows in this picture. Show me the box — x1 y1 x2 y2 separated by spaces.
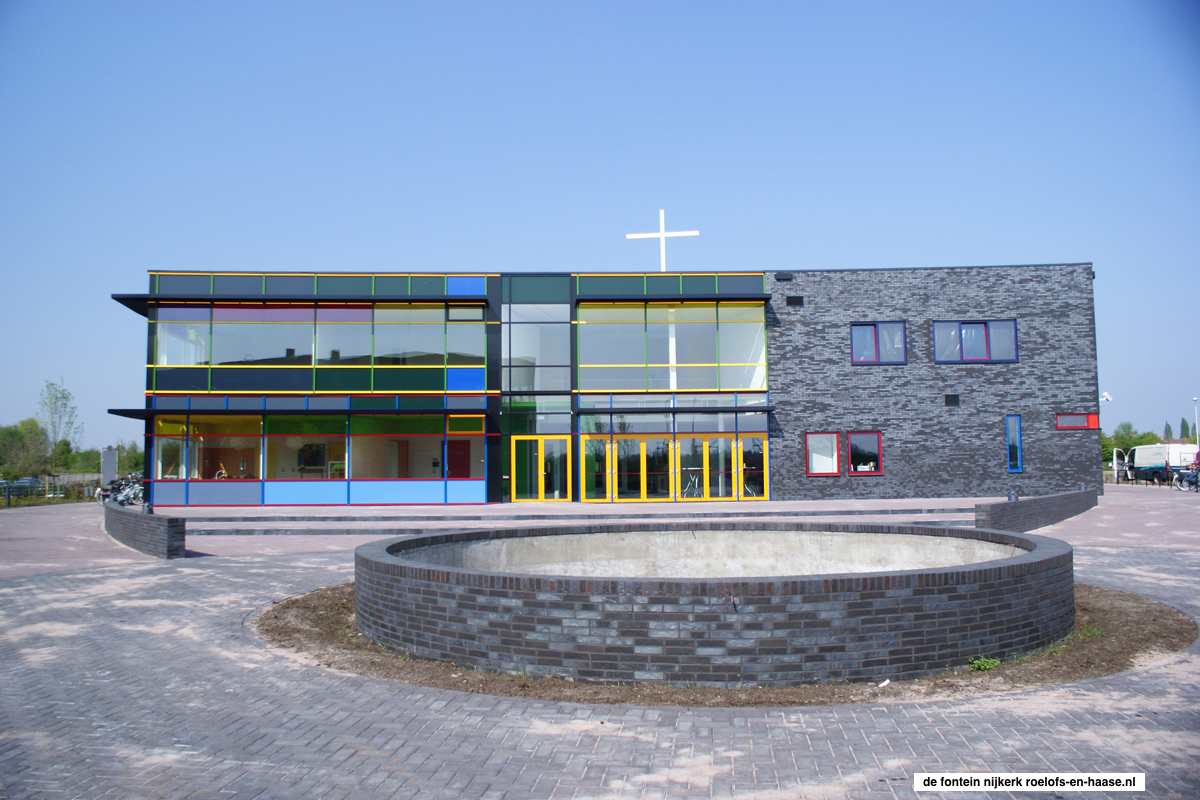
767 264 1103 500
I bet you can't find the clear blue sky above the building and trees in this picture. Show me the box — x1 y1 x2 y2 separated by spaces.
0 0 1200 445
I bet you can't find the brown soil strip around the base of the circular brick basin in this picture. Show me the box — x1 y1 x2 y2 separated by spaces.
256 583 1196 706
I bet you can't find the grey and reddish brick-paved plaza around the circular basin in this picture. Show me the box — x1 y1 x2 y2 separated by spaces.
0 486 1200 800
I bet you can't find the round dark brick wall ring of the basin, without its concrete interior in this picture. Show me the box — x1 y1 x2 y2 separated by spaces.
355 522 1075 686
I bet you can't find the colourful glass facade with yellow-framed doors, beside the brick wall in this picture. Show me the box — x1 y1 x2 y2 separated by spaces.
114 272 769 506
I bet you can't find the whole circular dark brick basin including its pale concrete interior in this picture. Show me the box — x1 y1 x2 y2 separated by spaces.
355 522 1075 686
